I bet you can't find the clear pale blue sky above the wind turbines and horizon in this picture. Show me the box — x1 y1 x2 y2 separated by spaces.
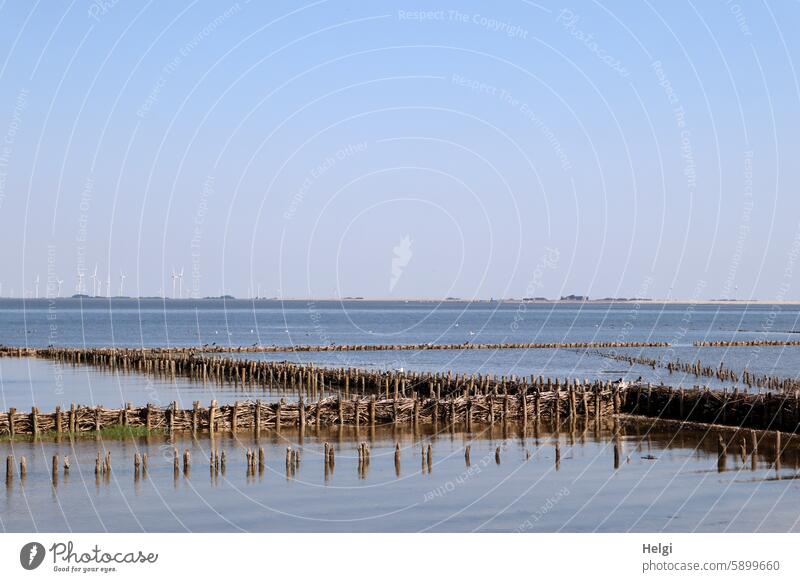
0 0 800 300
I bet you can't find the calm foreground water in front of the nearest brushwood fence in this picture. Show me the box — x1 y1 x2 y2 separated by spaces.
0 422 800 532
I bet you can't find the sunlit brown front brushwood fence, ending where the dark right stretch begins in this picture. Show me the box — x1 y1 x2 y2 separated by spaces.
0 390 627 437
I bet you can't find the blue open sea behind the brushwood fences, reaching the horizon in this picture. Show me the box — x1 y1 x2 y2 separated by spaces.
0 299 800 387
